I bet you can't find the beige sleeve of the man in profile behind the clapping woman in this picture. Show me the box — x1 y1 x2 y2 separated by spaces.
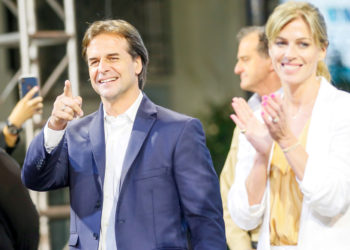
220 127 251 250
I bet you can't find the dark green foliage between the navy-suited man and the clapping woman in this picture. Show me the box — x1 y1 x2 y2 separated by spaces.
202 102 235 175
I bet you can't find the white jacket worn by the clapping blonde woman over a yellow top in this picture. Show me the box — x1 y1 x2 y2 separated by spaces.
228 78 350 250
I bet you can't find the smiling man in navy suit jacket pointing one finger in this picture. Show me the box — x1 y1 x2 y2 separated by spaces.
22 20 226 250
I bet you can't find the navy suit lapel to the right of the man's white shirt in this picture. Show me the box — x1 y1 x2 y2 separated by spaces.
120 94 157 187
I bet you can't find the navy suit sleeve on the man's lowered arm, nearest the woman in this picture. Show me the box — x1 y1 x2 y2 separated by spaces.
174 119 226 250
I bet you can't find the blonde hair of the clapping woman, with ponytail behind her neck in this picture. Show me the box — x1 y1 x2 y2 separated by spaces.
266 1 331 81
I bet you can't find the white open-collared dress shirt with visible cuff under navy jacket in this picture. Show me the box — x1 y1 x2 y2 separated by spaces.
44 91 143 250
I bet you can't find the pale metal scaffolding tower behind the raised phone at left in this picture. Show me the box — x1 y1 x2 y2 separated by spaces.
0 0 79 250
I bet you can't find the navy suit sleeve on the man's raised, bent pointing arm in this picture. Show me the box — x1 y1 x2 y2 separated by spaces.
22 131 69 191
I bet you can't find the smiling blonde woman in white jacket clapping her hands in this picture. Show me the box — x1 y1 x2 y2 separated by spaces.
229 2 350 250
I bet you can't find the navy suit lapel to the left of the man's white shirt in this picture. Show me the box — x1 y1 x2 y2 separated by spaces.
89 104 106 188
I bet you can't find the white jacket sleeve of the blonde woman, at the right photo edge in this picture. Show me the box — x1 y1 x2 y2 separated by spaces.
301 92 350 217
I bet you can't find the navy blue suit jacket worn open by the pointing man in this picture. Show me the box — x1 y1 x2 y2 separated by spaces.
22 96 226 250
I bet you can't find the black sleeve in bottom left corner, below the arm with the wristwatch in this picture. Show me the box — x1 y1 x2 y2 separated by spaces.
0 149 39 250
